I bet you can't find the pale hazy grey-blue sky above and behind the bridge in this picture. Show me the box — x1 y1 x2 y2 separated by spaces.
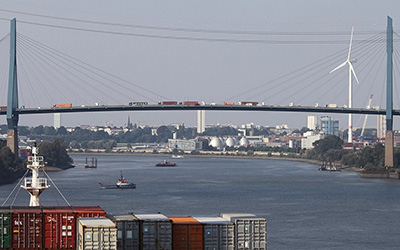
0 0 400 129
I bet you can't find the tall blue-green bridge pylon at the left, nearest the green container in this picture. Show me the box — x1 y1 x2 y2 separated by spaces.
7 18 19 155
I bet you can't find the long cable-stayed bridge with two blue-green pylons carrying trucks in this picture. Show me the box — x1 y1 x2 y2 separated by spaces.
0 16 400 166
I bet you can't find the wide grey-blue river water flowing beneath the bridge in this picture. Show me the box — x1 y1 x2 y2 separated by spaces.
0 155 400 250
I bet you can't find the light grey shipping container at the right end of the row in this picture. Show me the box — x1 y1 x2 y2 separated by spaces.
220 213 267 250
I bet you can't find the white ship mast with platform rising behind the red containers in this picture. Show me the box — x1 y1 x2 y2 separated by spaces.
21 145 50 207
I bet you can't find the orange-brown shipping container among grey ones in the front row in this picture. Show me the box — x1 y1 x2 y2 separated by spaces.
169 217 203 250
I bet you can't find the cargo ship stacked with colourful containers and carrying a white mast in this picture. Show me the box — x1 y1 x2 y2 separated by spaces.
0 146 267 250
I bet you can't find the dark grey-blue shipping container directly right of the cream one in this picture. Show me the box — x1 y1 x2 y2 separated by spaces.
110 214 140 250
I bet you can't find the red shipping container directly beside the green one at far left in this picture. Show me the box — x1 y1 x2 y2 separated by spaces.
11 207 43 249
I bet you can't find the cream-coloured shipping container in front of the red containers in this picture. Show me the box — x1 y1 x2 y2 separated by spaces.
77 218 117 250
